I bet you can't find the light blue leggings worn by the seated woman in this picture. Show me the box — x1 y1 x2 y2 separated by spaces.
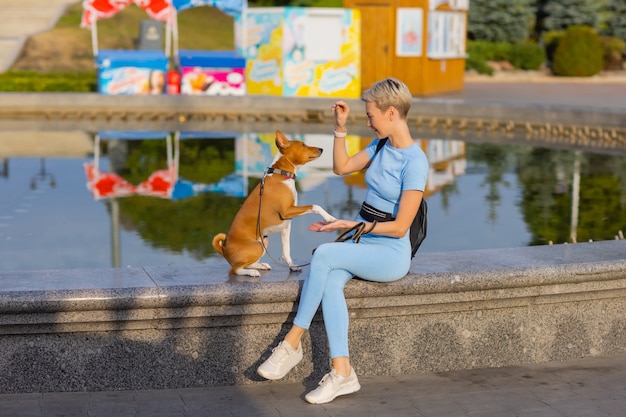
294 238 411 358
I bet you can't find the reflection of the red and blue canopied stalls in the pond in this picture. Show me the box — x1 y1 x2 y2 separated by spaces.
84 131 247 200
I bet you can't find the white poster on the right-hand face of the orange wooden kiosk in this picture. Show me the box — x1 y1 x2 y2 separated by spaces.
427 12 466 59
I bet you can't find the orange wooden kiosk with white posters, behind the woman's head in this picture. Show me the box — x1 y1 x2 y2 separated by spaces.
343 0 469 96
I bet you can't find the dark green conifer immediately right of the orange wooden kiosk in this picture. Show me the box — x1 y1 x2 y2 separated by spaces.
467 0 534 43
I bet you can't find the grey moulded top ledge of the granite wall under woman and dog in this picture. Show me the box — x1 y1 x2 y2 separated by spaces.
0 241 626 334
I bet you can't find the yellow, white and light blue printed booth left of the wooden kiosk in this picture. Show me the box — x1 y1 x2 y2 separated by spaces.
235 7 361 98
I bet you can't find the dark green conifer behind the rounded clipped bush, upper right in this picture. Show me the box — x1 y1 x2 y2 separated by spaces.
542 0 604 30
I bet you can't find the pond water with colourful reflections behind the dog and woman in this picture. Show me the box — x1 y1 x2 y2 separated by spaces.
0 132 626 271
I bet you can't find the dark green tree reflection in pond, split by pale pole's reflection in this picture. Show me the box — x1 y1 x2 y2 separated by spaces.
518 148 626 245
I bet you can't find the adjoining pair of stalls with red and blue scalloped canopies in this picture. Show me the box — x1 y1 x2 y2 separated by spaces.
81 0 247 95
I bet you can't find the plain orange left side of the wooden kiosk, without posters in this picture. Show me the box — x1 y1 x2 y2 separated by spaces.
344 0 395 90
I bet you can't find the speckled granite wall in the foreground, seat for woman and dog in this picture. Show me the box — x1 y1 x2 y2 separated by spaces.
0 241 626 392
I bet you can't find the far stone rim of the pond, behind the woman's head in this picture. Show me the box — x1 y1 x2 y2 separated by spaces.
0 93 626 132
